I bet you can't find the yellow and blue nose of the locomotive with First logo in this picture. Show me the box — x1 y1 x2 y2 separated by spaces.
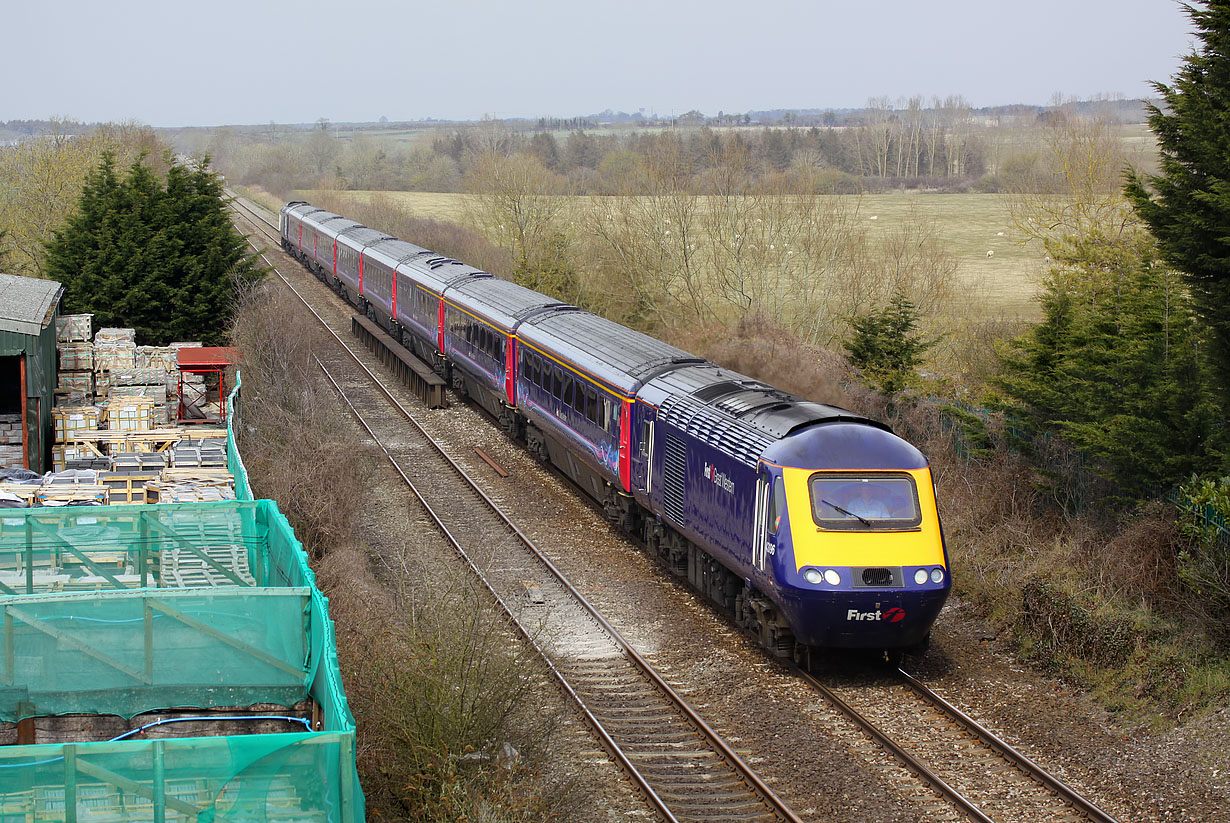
759 421 951 651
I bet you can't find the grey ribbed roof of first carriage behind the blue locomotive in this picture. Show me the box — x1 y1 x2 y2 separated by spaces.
517 309 704 395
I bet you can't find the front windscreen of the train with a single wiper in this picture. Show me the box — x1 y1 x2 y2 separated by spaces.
808 474 923 530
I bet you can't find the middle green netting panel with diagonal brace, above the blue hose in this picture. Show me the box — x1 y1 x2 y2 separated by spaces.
0 588 311 721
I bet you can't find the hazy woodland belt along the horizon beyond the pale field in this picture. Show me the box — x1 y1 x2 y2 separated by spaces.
175 96 1143 194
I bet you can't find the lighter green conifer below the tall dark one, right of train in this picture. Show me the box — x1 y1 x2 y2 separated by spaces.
1000 227 1216 495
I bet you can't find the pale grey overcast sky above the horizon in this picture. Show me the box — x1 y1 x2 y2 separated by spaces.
0 0 1193 125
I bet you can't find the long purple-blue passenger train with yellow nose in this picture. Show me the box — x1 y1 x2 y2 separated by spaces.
279 201 952 661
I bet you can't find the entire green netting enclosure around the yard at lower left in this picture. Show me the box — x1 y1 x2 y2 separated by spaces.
0 494 364 823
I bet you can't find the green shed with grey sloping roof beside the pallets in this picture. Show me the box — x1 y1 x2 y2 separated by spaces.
0 274 64 472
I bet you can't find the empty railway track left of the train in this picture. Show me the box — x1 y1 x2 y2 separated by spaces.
230 195 801 823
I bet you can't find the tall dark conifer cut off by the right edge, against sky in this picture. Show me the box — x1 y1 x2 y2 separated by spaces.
1125 0 1230 410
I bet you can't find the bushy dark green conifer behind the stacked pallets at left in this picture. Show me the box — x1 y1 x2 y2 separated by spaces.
47 155 261 344
